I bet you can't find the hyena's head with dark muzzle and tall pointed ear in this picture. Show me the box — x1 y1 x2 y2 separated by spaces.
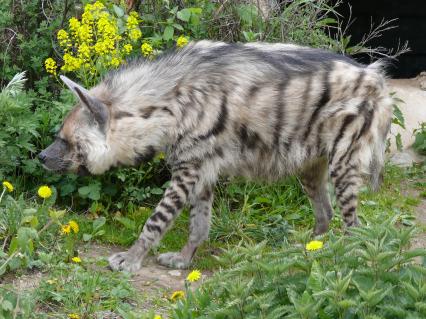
38 76 111 175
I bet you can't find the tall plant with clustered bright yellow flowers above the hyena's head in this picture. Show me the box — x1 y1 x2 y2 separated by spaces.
45 1 147 86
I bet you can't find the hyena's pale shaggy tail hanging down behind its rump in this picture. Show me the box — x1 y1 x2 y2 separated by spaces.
366 60 392 191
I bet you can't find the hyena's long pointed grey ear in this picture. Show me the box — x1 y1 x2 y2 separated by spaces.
60 75 109 128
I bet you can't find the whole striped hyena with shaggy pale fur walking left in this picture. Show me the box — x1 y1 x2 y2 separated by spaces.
39 41 392 271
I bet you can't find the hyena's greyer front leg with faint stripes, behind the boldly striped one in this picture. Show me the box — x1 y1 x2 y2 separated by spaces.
158 186 213 269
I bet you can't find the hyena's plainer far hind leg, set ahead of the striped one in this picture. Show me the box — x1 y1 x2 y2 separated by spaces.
300 158 333 235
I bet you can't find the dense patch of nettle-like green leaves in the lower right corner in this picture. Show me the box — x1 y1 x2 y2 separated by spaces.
172 216 426 319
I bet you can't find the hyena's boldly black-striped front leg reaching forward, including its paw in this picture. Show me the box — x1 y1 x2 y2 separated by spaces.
109 165 198 272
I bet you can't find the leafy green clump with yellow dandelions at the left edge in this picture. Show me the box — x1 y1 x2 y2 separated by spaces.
0 183 79 275
